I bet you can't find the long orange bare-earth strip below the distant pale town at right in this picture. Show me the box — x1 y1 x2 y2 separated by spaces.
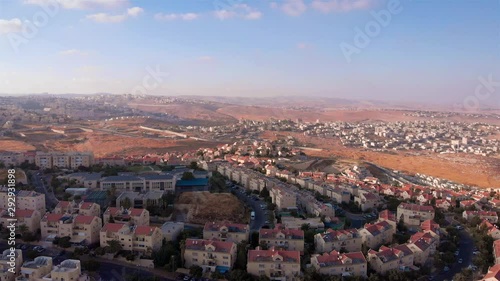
262 132 500 188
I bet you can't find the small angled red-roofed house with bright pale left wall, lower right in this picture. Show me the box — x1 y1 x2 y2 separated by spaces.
359 221 396 249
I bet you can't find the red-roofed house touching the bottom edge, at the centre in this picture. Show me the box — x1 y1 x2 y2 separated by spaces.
247 247 300 281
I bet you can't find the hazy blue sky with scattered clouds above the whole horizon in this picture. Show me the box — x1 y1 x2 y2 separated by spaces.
0 0 500 103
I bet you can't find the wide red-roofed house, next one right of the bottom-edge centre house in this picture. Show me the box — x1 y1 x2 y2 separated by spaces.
311 250 368 277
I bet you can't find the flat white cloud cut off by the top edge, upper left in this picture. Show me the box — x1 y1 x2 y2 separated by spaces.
24 0 128 10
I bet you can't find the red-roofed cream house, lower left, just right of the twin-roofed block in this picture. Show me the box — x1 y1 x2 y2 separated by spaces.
99 223 163 252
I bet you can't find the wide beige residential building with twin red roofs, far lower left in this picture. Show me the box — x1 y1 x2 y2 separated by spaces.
40 213 102 245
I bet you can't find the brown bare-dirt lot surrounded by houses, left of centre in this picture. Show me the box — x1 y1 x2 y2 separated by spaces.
175 192 247 224
